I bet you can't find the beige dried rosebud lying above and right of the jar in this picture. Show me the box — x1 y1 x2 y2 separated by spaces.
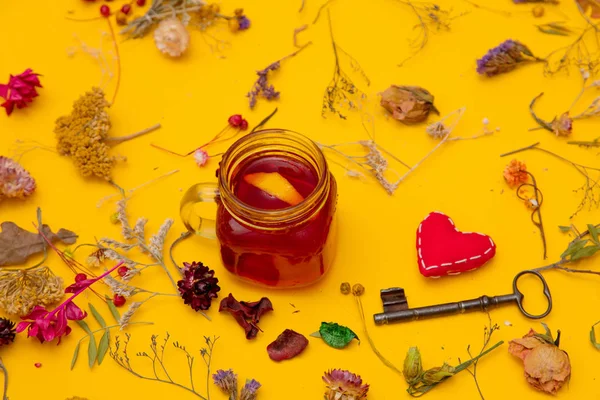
381 85 440 124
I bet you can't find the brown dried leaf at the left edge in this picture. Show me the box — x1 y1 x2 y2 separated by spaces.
0 222 77 266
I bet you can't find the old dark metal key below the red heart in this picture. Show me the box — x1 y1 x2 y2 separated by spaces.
373 270 552 325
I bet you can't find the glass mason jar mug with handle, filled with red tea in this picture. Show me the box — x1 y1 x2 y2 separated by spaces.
180 129 337 288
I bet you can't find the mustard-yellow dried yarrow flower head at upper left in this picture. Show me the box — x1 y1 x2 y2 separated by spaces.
54 87 115 180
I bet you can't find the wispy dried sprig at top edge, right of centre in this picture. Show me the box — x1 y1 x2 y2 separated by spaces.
398 0 466 67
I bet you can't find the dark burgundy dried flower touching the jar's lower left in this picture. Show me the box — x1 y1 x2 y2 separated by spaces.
177 261 221 311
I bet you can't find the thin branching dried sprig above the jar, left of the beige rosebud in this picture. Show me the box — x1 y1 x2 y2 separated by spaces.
321 10 371 119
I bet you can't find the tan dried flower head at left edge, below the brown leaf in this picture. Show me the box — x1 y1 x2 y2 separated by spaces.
0 267 64 317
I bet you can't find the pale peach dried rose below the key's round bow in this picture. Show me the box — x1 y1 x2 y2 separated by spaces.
508 325 571 394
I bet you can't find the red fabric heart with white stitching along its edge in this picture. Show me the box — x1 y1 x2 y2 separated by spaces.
417 211 496 278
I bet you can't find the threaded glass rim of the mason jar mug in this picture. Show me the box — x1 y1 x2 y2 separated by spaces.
219 128 329 224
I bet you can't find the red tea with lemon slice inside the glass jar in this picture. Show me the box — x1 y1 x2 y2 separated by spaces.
217 155 337 287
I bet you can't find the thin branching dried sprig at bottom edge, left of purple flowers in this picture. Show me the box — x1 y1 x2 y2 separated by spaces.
109 332 219 400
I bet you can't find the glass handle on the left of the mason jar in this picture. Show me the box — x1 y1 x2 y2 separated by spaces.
179 183 219 239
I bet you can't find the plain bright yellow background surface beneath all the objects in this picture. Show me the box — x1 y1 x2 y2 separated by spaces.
0 0 600 400
